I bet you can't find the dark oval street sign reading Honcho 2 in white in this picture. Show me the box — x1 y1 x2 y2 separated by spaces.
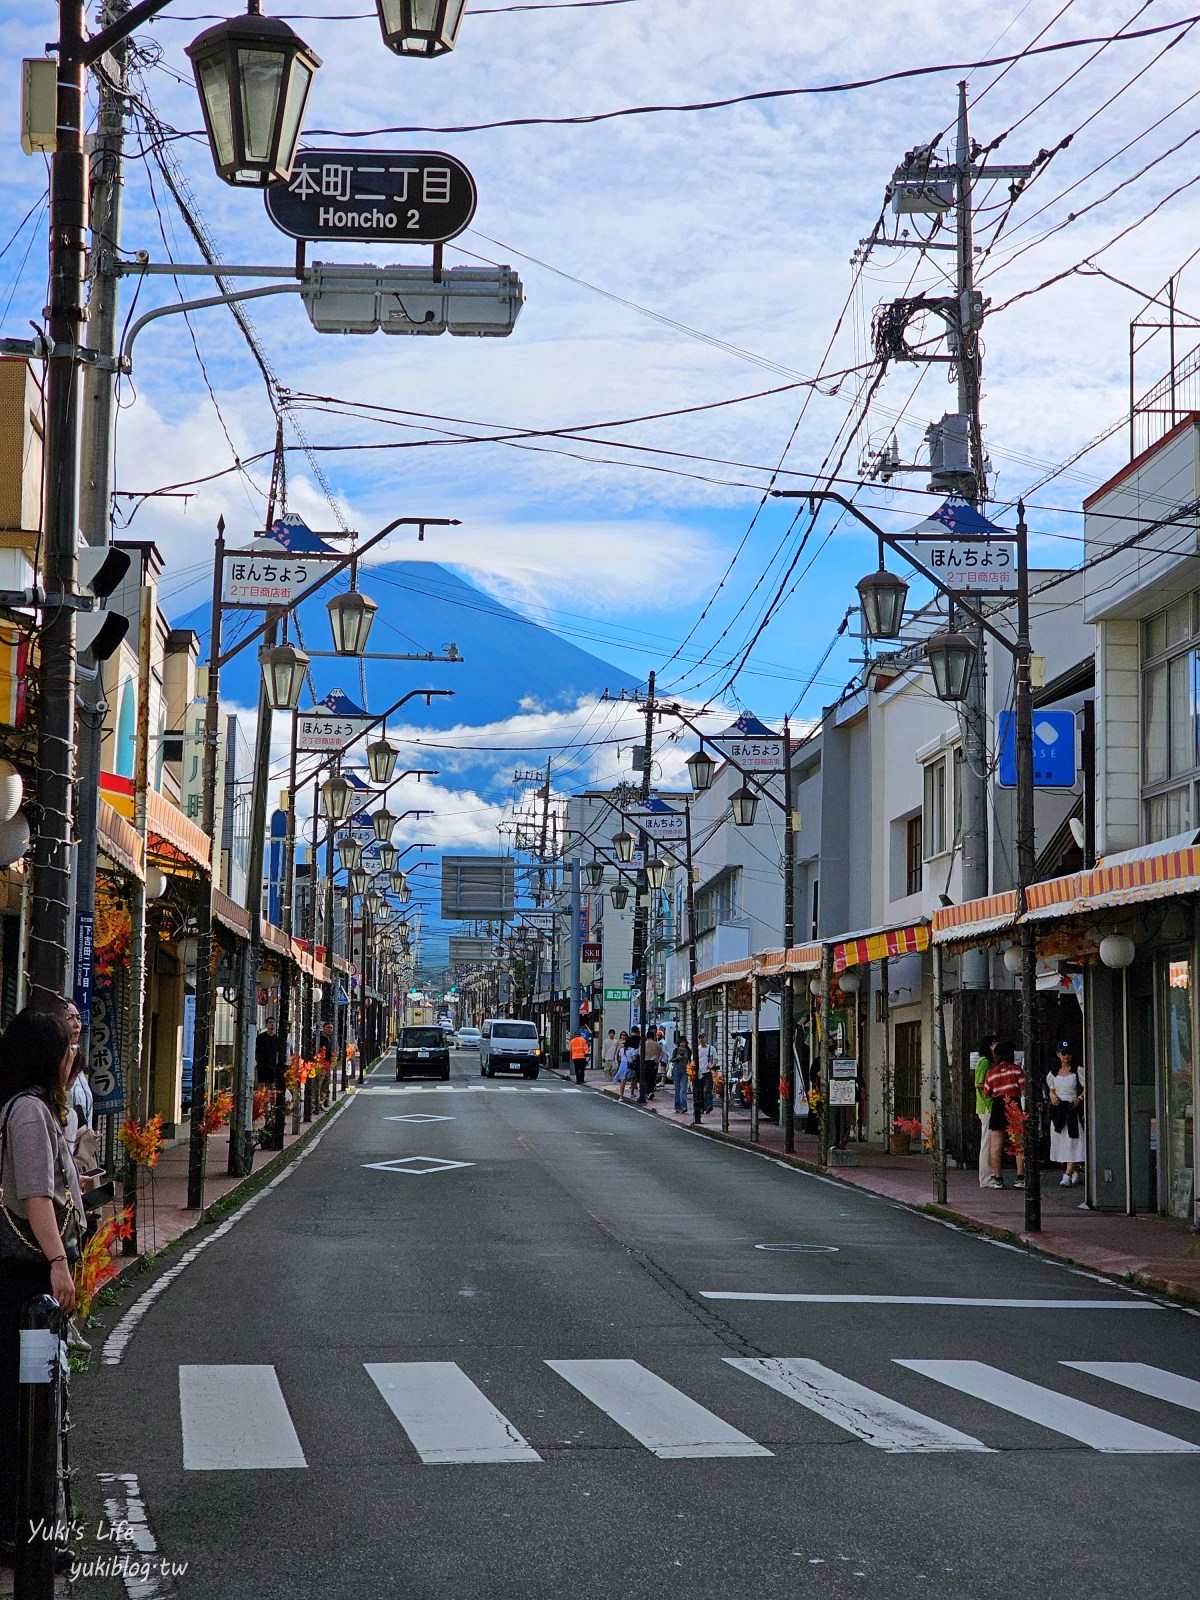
262 150 478 245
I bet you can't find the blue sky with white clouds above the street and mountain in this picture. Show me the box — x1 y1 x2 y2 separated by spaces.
0 0 1200 960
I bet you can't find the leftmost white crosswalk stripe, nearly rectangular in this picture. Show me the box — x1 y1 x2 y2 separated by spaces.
179 1366 309 1472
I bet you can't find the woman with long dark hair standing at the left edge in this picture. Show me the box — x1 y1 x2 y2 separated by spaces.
0 1010 83 1547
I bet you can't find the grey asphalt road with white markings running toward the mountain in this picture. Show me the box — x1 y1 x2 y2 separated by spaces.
72 1053 1200 1600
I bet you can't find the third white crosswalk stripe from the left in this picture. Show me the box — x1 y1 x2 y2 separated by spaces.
546 1360 771 1461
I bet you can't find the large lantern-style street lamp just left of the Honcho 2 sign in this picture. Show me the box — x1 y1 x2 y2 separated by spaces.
186 0 322 189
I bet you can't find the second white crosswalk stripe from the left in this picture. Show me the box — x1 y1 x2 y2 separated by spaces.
363 1362 542 1466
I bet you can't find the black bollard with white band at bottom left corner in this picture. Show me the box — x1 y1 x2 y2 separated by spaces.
13 1294 67 1600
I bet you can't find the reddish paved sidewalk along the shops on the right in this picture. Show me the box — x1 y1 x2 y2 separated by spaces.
562 1072 1200 1304
